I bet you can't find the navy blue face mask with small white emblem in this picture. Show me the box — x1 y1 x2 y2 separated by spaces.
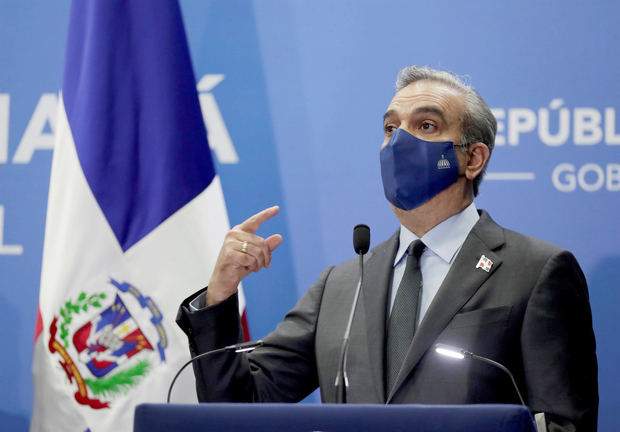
381 129 459 210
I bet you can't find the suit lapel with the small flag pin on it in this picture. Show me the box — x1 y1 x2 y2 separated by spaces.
384 211 504 402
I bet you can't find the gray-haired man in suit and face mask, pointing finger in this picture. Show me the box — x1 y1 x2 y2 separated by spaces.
177 66 598 431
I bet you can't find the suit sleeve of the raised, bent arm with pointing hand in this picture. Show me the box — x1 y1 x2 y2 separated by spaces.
177 267 332 402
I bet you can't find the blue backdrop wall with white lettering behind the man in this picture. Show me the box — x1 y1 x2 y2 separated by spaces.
0 0 620 431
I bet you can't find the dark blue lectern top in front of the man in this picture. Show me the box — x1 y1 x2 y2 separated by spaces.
134 403 536 432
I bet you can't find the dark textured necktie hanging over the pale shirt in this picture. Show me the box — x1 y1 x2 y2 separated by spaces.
385 240 426 395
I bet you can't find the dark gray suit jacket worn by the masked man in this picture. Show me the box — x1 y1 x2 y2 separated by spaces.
177 211 598 431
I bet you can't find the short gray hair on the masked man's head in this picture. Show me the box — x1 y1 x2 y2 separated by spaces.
396 66 497 196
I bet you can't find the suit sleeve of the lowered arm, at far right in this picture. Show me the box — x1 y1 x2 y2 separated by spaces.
521 251 598 432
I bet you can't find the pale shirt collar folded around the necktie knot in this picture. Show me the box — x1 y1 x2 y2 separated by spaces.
394 202 480 266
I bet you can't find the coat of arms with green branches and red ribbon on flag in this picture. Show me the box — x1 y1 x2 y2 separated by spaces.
48 279 167 409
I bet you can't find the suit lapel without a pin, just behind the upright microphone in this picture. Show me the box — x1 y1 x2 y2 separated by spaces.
362 230 399 400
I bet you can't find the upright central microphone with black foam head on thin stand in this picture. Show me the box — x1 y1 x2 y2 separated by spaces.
334 224 370 403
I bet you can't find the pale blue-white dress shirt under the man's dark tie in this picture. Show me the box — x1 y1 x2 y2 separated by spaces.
388 202 480 324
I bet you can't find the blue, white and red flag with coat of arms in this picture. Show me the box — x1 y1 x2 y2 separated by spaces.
31 0 245 432
